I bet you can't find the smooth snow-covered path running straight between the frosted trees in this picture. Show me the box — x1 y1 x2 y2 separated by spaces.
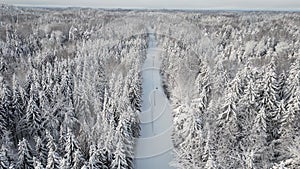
134 32 173 169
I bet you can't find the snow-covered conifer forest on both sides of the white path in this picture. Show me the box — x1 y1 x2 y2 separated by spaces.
0 5 300 169
